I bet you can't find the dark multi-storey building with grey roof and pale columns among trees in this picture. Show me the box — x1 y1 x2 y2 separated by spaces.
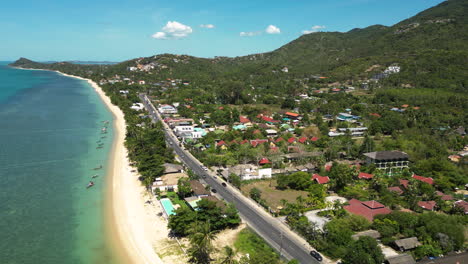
364 150 409 169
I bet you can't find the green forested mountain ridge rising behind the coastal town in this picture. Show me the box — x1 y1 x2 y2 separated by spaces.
13 0 468 93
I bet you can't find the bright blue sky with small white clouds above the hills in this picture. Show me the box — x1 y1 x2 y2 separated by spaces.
0 0 443 61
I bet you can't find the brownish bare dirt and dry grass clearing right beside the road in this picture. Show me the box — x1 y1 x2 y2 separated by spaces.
241 180 308 209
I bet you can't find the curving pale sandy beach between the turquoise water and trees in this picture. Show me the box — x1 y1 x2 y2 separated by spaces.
15 67 171 264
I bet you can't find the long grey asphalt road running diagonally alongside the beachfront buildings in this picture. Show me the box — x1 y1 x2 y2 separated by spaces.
140 95 319 264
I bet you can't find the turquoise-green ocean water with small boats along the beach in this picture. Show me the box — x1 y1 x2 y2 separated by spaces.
0 63 119 264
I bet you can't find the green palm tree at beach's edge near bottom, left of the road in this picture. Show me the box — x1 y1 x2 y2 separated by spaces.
188 222 216 264
